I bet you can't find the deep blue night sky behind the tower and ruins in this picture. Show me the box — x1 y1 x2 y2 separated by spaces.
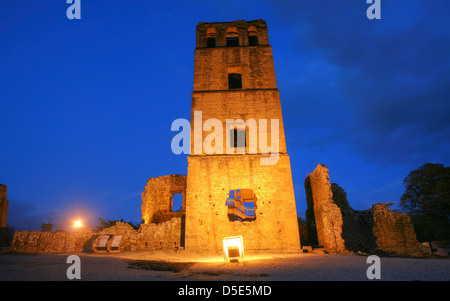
0 0 450 230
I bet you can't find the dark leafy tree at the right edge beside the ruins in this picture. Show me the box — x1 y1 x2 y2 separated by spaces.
400 163 450 241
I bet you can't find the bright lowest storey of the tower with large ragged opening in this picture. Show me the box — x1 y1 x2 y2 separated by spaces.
186 155 300 251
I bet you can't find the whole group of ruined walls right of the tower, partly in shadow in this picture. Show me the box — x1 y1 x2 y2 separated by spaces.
305 164 424 257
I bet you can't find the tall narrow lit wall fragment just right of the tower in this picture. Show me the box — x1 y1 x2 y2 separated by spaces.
306 164 346 253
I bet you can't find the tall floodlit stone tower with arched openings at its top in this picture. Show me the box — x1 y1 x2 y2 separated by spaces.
185 20 300 251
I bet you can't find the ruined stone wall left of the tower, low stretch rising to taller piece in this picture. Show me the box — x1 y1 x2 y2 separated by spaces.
12 175 186 253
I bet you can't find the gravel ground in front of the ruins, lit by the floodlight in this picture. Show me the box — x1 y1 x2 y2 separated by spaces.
0 251 450 281
